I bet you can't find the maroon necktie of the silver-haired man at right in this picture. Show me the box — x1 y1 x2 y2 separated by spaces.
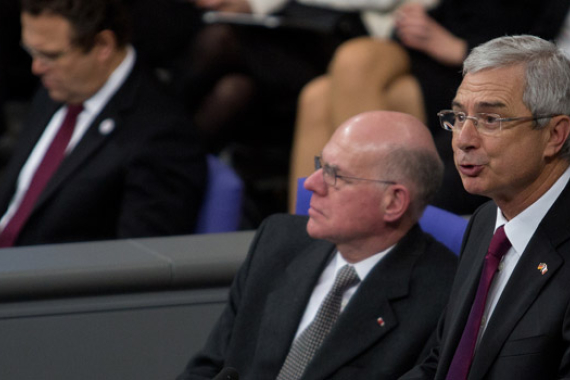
446 226 511 380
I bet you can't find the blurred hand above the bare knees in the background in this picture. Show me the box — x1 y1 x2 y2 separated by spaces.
396 3 467 66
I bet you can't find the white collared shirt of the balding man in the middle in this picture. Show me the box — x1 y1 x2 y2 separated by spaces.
295 246 394 339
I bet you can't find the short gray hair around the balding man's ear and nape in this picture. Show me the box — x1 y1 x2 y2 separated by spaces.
382 146 443 219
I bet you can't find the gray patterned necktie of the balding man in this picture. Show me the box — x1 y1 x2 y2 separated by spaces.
277 265 360 380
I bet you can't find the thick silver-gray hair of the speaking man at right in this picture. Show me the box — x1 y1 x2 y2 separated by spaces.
463 35 570 161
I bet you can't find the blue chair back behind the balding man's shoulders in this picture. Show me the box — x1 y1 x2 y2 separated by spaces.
295 178 467 255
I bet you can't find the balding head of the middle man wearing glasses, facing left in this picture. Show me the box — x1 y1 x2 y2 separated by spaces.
305 111 443 262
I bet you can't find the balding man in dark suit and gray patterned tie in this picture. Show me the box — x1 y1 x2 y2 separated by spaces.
180 111 456 380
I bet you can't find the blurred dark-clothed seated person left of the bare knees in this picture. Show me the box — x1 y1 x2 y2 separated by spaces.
173 0 366 153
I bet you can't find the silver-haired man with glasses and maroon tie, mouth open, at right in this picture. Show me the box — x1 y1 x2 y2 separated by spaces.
403 36 570 380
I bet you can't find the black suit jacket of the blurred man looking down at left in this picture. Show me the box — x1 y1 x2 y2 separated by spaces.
0 56 206 245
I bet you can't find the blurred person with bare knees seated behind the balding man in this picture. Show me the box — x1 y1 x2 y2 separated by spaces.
289 0 570 215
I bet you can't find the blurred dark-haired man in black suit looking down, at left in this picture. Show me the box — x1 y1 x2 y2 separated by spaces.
0 0 206 247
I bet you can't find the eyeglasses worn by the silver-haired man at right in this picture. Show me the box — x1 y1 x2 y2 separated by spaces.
437 110 560 135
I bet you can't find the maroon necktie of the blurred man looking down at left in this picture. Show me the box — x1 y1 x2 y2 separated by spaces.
0 104 83 248
